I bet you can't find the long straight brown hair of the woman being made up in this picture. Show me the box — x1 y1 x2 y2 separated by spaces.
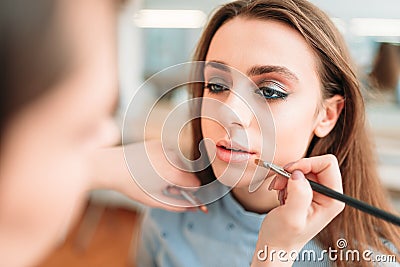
191 0 400 266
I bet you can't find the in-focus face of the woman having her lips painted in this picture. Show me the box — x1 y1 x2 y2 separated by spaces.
201 17 322 187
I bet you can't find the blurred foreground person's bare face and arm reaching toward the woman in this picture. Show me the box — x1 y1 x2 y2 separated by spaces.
0 0 199 266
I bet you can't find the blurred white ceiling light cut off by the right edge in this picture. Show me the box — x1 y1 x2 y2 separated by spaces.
350 18 400 37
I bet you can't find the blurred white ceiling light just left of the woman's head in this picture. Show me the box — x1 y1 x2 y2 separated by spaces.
134 9 207 28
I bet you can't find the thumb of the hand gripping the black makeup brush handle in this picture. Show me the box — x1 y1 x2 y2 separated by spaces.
284 170 313 223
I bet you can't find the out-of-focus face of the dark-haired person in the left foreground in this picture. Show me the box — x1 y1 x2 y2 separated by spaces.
0 0 118 265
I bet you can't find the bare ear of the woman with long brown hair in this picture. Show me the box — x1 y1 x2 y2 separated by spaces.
314 95 344 138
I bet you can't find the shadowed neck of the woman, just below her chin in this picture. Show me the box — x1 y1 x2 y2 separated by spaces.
232 178 279 214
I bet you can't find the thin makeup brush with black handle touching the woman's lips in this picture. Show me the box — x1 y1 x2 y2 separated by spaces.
255 159 400 226
